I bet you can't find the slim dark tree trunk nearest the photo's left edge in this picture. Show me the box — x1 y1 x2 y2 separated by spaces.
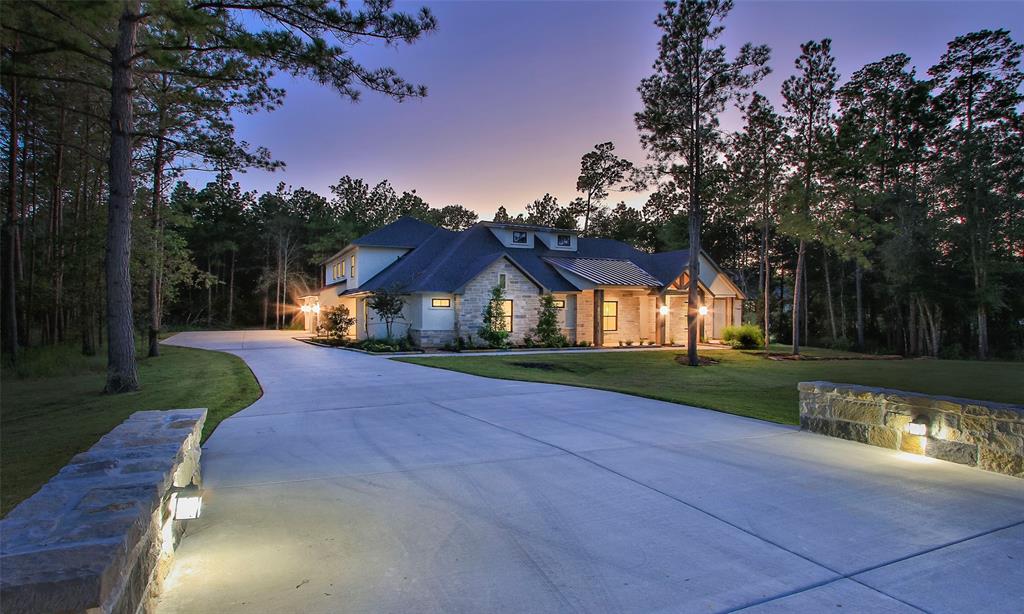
0 66 19 362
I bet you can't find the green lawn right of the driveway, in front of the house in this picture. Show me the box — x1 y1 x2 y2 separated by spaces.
396 348 1024 424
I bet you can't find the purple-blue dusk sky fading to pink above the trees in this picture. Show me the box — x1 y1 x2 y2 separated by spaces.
209 0 1024 219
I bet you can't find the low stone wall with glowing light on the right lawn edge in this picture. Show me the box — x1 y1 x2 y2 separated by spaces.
799 382 1024 478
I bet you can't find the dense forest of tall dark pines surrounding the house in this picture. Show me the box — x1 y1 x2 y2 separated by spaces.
0 0 1024 390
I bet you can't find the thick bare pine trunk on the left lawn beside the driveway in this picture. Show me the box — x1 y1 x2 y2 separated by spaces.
105 0 140 393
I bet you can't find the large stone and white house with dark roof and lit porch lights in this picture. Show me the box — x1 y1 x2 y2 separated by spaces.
303 218 745 347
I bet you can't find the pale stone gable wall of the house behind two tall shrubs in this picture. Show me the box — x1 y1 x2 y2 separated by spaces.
456 258 541 344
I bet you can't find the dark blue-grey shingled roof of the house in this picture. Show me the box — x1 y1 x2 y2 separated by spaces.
342 218 737 295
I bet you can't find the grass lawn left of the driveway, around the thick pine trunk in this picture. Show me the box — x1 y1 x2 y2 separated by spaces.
0 346 261 515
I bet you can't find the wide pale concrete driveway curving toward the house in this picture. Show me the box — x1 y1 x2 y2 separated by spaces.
159 332 1024 614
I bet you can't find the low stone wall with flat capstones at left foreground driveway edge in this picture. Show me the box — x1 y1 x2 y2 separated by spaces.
0 409 206 614
